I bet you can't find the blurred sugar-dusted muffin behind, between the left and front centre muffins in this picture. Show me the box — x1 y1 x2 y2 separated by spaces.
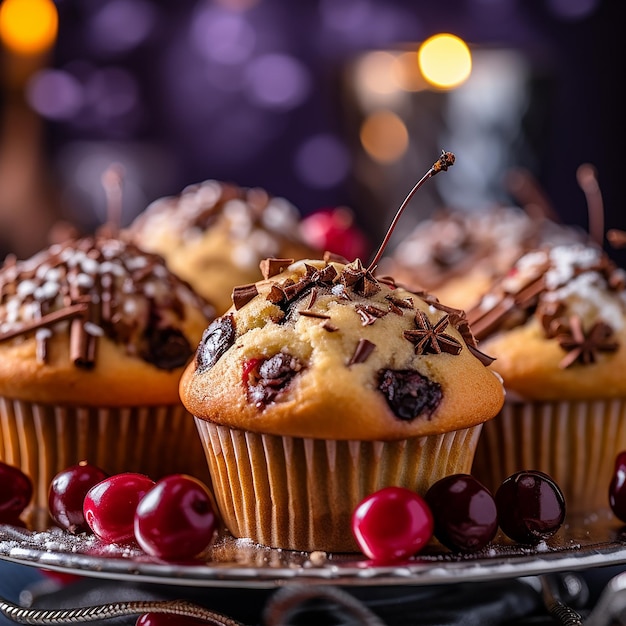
127 180 319 314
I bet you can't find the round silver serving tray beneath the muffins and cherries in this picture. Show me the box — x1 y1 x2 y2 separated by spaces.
0 512 626 588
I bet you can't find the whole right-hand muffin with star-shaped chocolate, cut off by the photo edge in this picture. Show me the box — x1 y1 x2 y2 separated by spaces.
468 244 626 514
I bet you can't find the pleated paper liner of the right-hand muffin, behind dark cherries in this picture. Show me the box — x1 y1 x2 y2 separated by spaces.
472 399 626 515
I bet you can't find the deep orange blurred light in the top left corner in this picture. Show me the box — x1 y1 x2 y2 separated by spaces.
0 0 59 54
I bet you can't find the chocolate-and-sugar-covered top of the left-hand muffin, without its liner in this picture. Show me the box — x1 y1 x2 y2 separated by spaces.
0 237 215 406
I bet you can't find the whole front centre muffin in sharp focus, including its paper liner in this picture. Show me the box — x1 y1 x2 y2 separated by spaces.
180 256 503 552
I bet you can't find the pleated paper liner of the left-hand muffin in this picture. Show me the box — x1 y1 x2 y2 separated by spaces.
0 398 209 526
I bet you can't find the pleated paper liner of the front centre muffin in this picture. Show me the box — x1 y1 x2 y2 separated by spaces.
196 418 482 552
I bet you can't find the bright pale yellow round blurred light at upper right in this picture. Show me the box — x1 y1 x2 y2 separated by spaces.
417 33 472 89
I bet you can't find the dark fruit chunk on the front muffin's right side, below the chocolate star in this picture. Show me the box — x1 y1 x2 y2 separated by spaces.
378 370 443 421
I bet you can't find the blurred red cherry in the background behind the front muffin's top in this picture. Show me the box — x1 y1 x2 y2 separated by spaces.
301 207 369 260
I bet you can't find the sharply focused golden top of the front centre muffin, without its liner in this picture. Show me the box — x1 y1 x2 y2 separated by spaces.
180 258 503 441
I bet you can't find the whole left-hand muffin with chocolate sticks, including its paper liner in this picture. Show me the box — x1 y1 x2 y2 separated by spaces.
0 237 214 510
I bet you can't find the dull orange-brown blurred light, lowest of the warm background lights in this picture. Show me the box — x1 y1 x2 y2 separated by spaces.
360 111 409 164
